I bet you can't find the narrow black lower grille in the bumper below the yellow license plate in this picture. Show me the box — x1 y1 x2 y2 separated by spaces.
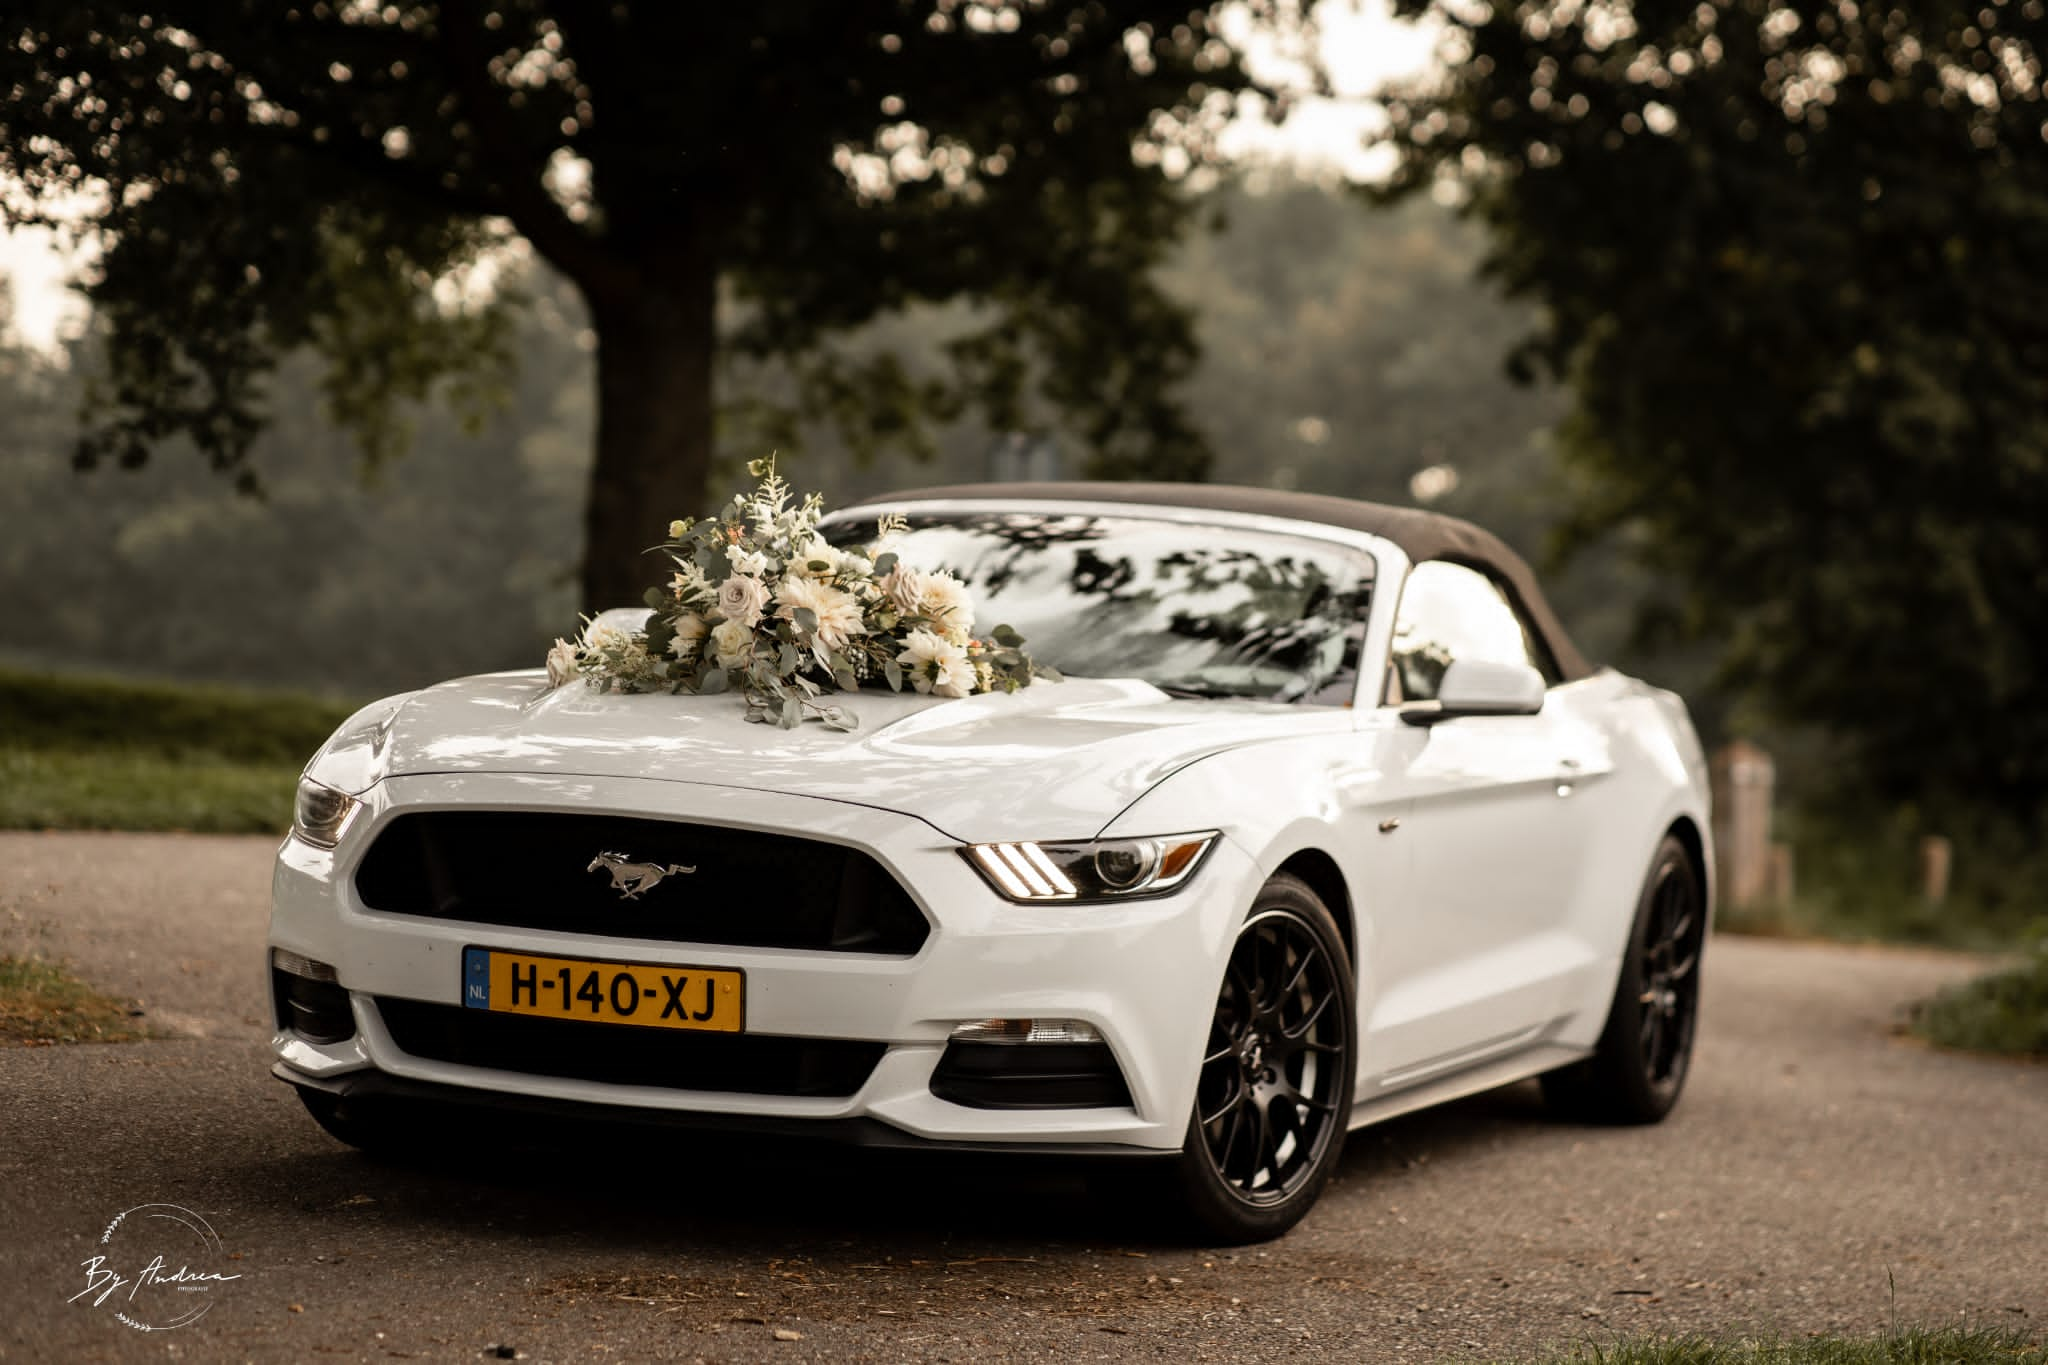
375 997 887 1097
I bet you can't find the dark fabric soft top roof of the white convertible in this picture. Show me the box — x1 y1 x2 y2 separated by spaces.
851 483 1593 681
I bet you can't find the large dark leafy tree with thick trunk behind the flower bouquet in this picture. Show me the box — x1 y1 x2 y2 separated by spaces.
0 0 1290 606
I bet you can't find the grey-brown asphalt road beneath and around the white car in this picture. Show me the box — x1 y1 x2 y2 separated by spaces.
0 833 2048 1361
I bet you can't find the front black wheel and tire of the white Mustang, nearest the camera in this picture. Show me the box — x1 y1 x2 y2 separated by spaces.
1171 876 1358 1244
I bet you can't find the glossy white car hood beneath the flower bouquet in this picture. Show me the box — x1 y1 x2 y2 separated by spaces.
327 671 1350 841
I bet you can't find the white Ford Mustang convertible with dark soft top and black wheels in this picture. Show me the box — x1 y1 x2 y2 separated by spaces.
270 485 1712 1240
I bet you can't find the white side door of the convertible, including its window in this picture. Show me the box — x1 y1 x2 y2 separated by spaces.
1362 561 1610 1097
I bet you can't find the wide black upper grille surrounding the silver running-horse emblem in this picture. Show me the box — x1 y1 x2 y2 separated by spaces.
356 810 930 956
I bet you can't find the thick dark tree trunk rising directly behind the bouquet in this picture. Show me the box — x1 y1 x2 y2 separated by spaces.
582 258 717 612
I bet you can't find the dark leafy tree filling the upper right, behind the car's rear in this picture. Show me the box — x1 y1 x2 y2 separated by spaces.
1391 0 2048 808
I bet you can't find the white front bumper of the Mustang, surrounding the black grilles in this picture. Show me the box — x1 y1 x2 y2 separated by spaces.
270 774 1260 1152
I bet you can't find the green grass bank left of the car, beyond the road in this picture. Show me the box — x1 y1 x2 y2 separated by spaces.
0 669 354 833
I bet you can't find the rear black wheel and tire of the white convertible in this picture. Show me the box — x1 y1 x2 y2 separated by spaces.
1542 835 1706 1124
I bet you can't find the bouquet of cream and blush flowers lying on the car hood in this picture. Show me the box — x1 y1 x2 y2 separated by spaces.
547 458 1057 731
